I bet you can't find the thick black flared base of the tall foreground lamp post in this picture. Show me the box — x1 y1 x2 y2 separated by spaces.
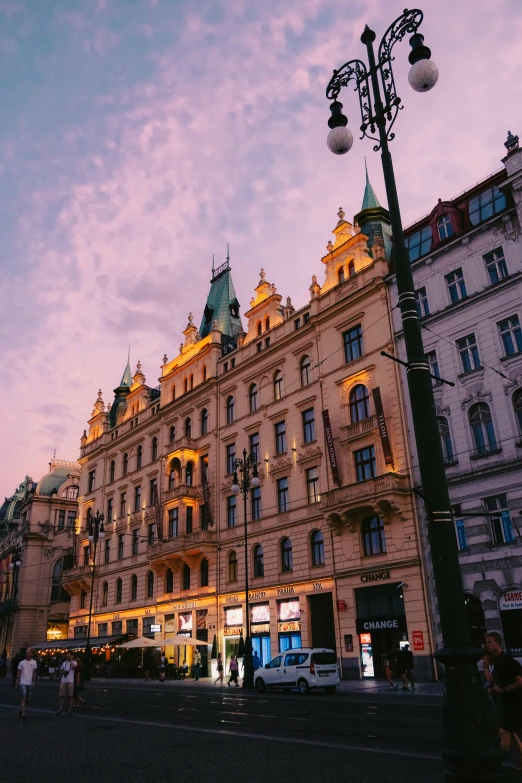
434 646 507 783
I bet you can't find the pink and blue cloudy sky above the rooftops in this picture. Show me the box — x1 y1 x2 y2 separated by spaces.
0 0 522 495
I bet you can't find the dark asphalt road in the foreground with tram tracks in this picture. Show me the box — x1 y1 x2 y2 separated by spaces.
0 678 517 783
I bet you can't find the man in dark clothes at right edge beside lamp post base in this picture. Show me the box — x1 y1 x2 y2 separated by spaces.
482 631 522 769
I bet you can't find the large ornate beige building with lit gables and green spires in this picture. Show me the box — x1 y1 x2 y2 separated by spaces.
68 194 432 678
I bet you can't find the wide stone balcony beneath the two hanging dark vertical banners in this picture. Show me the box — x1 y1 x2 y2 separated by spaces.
319 473 411 536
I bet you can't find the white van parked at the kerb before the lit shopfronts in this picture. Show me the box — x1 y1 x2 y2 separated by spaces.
254 647 341 693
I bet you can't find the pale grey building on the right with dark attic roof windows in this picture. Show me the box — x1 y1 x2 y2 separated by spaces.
389 134 522 657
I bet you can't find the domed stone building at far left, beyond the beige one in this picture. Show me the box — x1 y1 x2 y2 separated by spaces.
0 459 80 657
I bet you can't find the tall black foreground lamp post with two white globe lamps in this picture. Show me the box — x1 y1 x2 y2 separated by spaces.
326 9 504 783
